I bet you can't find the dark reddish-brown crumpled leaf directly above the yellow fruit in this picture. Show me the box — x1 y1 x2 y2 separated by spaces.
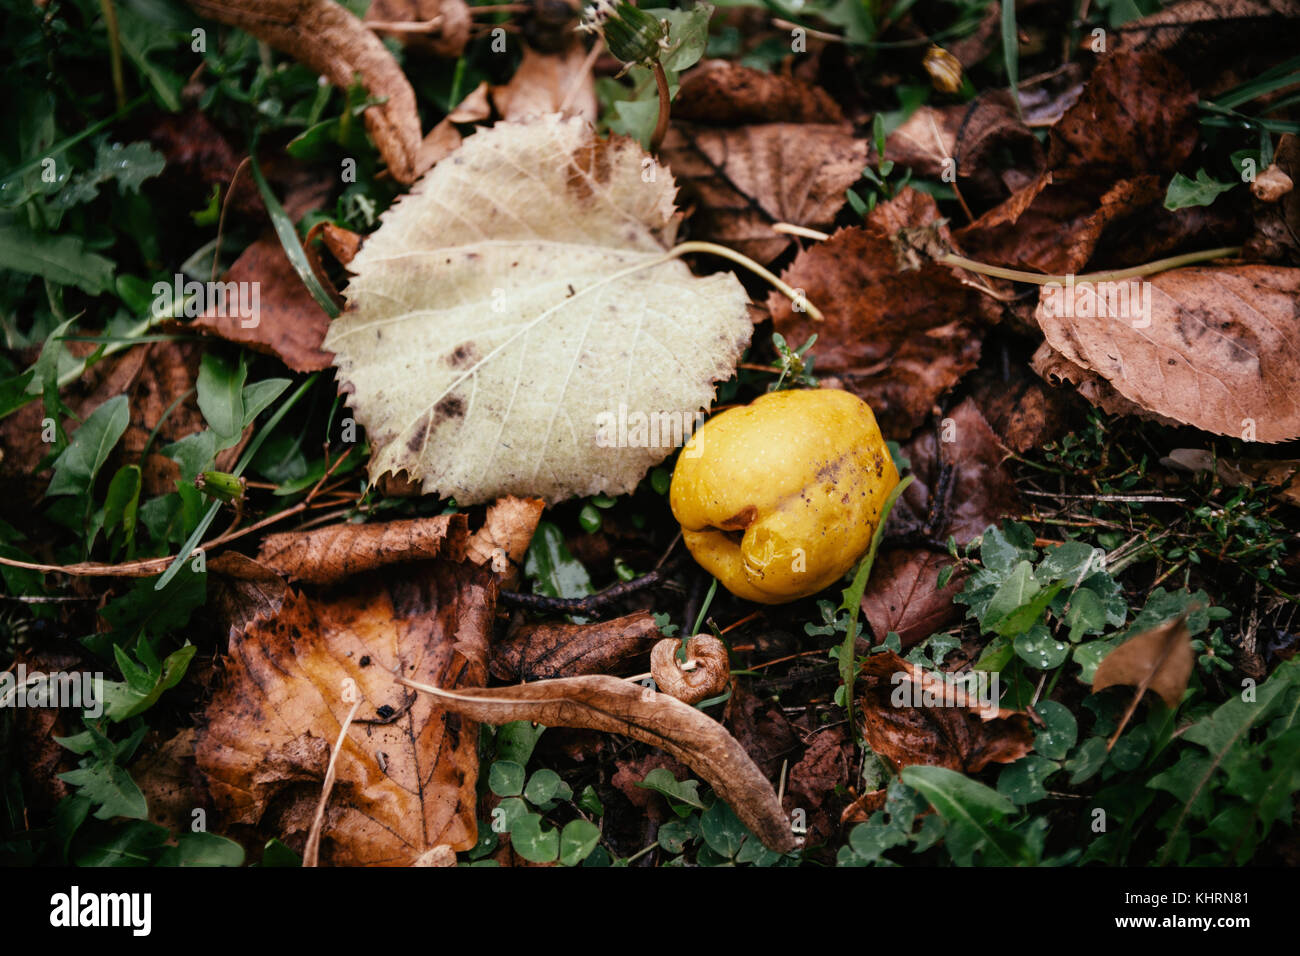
767 189 980 438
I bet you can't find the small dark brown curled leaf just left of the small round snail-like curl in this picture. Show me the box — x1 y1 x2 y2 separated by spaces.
489 611 660 682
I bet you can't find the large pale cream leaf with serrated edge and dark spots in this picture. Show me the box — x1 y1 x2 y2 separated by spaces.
326 116 751 505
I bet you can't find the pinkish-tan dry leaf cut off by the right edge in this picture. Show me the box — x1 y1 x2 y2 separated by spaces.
1035 265 1300 442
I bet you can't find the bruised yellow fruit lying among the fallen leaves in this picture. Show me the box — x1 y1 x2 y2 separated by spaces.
670 389 898 604
